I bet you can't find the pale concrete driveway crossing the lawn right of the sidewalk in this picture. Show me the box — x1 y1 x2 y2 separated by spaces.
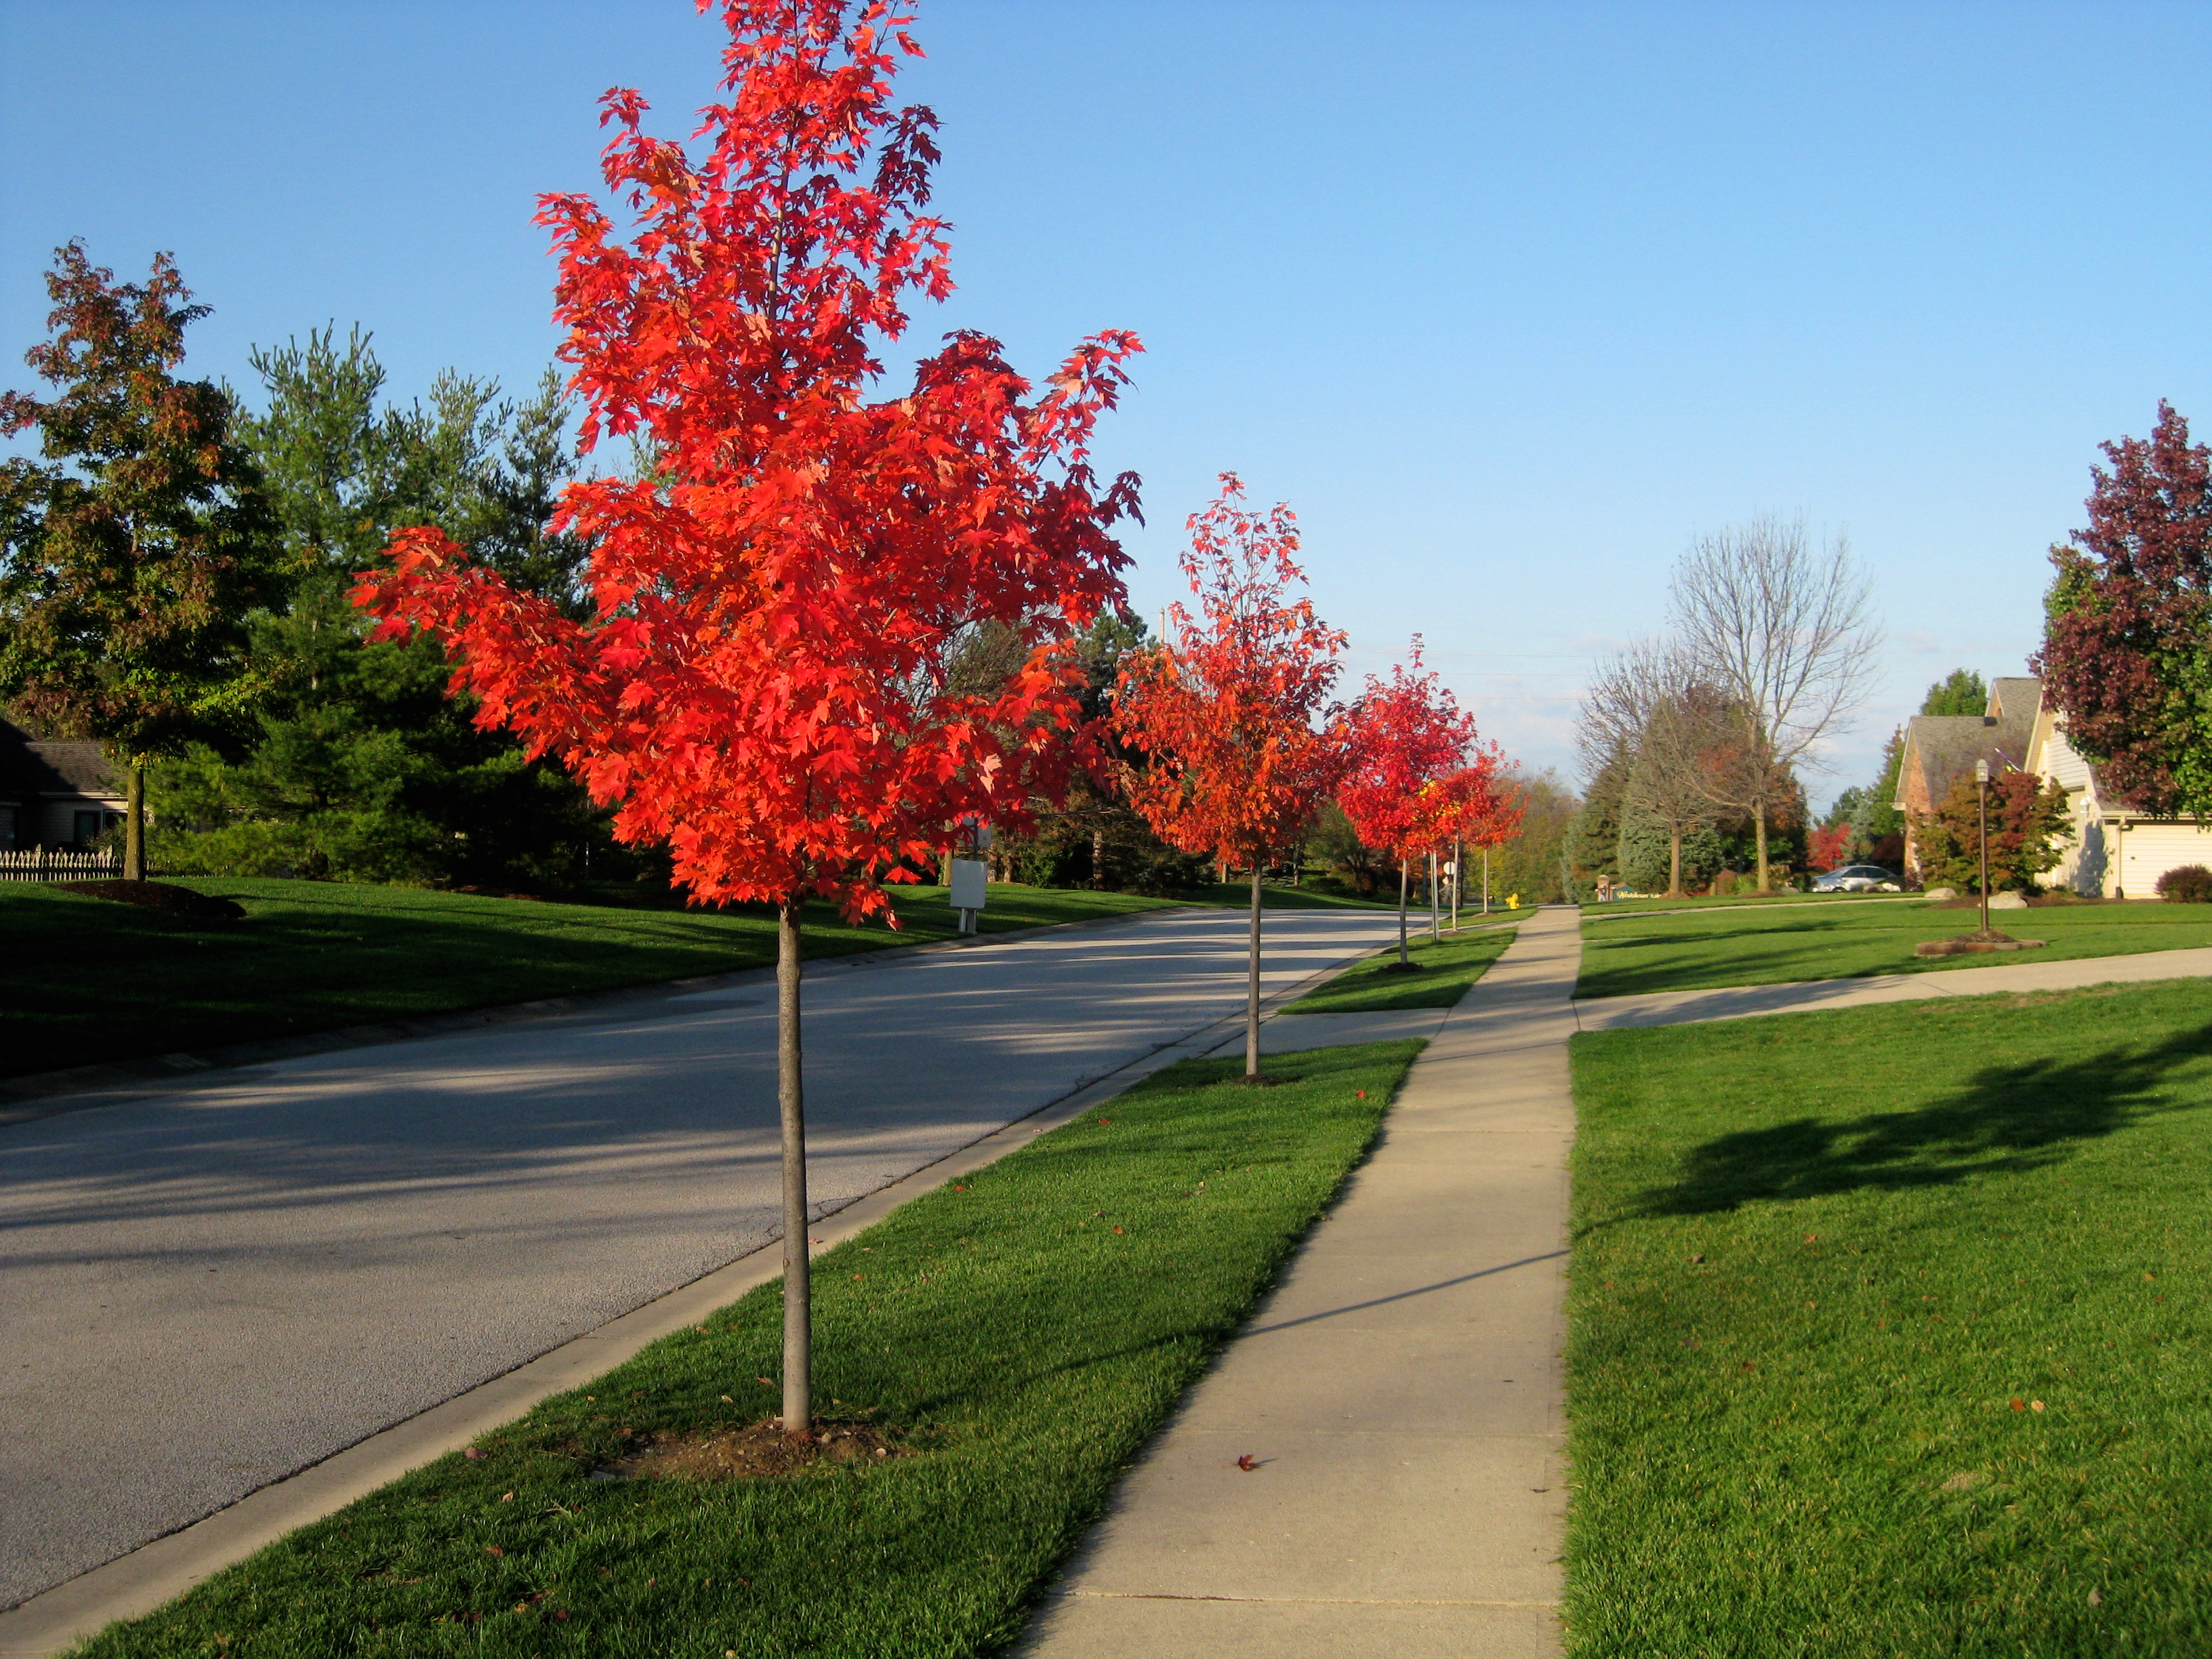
1573 951 2212 1031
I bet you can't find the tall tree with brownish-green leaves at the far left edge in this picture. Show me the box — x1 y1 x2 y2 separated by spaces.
0 241 276 880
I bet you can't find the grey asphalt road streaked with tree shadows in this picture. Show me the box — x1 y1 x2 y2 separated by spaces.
0 912 1396 1608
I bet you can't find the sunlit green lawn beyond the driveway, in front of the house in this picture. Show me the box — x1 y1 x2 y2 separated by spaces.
1575 903 2212 998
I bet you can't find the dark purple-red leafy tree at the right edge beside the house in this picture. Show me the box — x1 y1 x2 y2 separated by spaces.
2033 401 2212 814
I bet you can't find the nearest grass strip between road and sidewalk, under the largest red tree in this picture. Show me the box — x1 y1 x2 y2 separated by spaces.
77 1042 1420 1659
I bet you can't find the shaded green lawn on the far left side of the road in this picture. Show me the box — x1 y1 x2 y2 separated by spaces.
0 876 1168 1078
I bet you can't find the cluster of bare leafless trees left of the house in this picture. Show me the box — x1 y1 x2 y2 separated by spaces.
1575 518 1880 896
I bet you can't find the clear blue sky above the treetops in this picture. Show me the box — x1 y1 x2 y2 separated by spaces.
0 0 2212 798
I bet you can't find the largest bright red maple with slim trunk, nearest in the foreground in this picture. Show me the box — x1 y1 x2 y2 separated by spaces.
359 0 1139 1435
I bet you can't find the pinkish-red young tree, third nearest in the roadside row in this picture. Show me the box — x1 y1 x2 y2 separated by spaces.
1336 635 1475 966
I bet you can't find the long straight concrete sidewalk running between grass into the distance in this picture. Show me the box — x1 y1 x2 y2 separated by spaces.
1022 909 1582 1659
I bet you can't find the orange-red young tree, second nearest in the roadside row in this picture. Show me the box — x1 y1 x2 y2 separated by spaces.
1115 473 1345 1078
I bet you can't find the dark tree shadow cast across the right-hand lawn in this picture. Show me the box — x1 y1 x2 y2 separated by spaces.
1633 1024 2212 1216
